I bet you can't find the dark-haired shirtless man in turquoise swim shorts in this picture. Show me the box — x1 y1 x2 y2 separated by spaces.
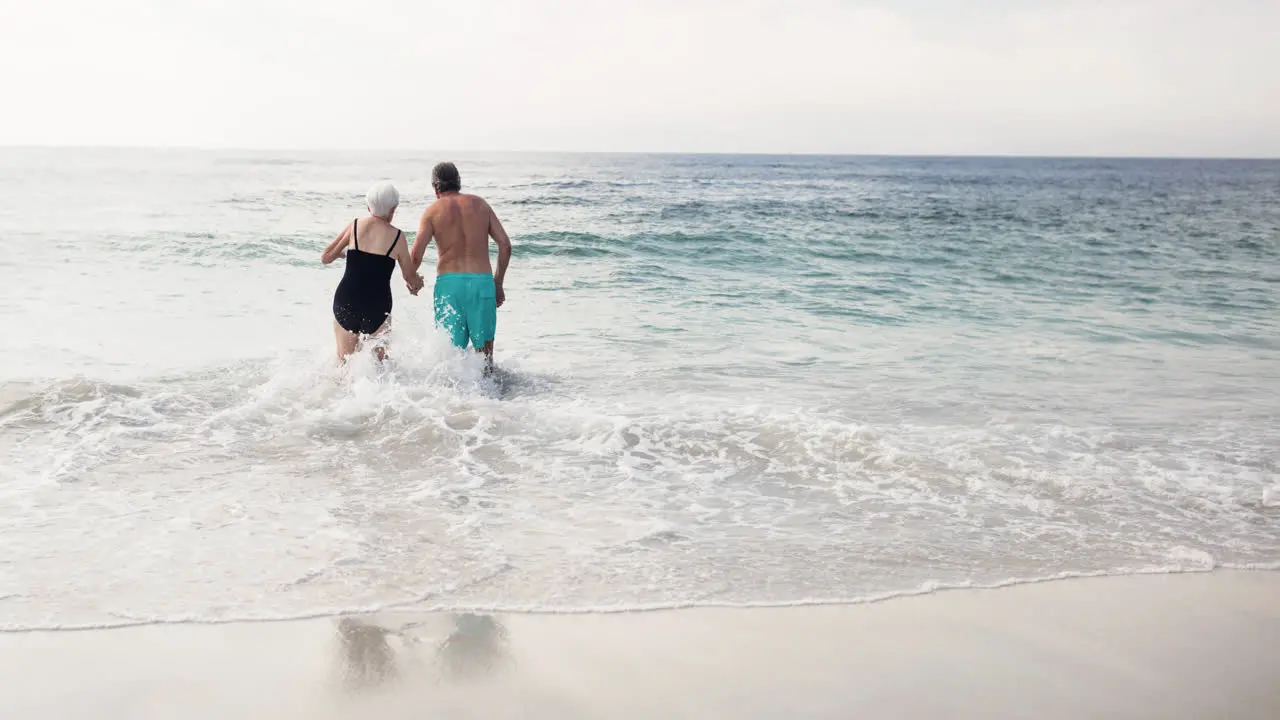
410 163 511 372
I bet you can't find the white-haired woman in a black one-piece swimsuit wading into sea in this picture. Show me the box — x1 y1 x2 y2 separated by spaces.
320 182 422 361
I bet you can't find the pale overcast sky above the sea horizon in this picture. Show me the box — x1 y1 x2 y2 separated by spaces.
0 0 1280 156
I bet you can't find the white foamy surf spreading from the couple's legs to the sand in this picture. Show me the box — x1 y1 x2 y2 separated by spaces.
0 333 1275 629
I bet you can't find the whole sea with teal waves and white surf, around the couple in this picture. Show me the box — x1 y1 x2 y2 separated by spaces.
0 149 1280 632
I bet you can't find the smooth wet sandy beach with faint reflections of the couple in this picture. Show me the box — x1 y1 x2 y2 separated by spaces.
0 571 1280 720
